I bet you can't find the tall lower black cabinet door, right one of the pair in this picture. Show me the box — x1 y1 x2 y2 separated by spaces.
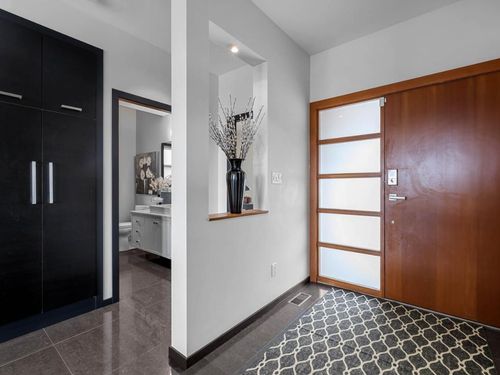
43 112 97 311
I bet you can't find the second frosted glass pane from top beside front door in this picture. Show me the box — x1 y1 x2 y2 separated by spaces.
319 138 380 174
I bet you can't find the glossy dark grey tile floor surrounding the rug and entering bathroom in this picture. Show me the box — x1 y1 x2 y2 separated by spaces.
0 250 500 375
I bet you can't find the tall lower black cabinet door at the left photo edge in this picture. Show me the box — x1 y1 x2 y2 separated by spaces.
0 103 42 325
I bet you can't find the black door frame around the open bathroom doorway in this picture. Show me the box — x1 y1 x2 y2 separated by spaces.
110 89 172 303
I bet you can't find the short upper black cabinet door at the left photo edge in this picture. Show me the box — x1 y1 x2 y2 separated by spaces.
0 17 42 107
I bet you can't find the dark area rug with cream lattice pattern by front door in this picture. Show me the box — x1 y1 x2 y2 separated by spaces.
243 288 496 375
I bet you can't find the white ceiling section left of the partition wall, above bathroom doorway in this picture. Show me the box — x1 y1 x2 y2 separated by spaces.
62 0 170 52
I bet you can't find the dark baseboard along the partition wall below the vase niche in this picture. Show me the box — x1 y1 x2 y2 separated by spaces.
168 277 309 371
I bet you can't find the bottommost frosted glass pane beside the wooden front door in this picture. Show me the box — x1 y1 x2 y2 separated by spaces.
319 247 380 290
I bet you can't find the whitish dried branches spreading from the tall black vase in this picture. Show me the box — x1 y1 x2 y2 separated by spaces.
209 95 264 160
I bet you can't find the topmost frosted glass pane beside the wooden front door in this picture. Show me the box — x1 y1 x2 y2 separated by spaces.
319 99 380 139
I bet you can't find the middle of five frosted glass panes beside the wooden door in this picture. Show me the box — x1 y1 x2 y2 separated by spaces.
319 177 380 212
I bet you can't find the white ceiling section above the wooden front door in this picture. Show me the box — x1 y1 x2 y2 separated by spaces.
252 0 458 54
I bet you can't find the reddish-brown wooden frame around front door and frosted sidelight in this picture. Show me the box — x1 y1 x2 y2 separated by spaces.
309 59 500 297
